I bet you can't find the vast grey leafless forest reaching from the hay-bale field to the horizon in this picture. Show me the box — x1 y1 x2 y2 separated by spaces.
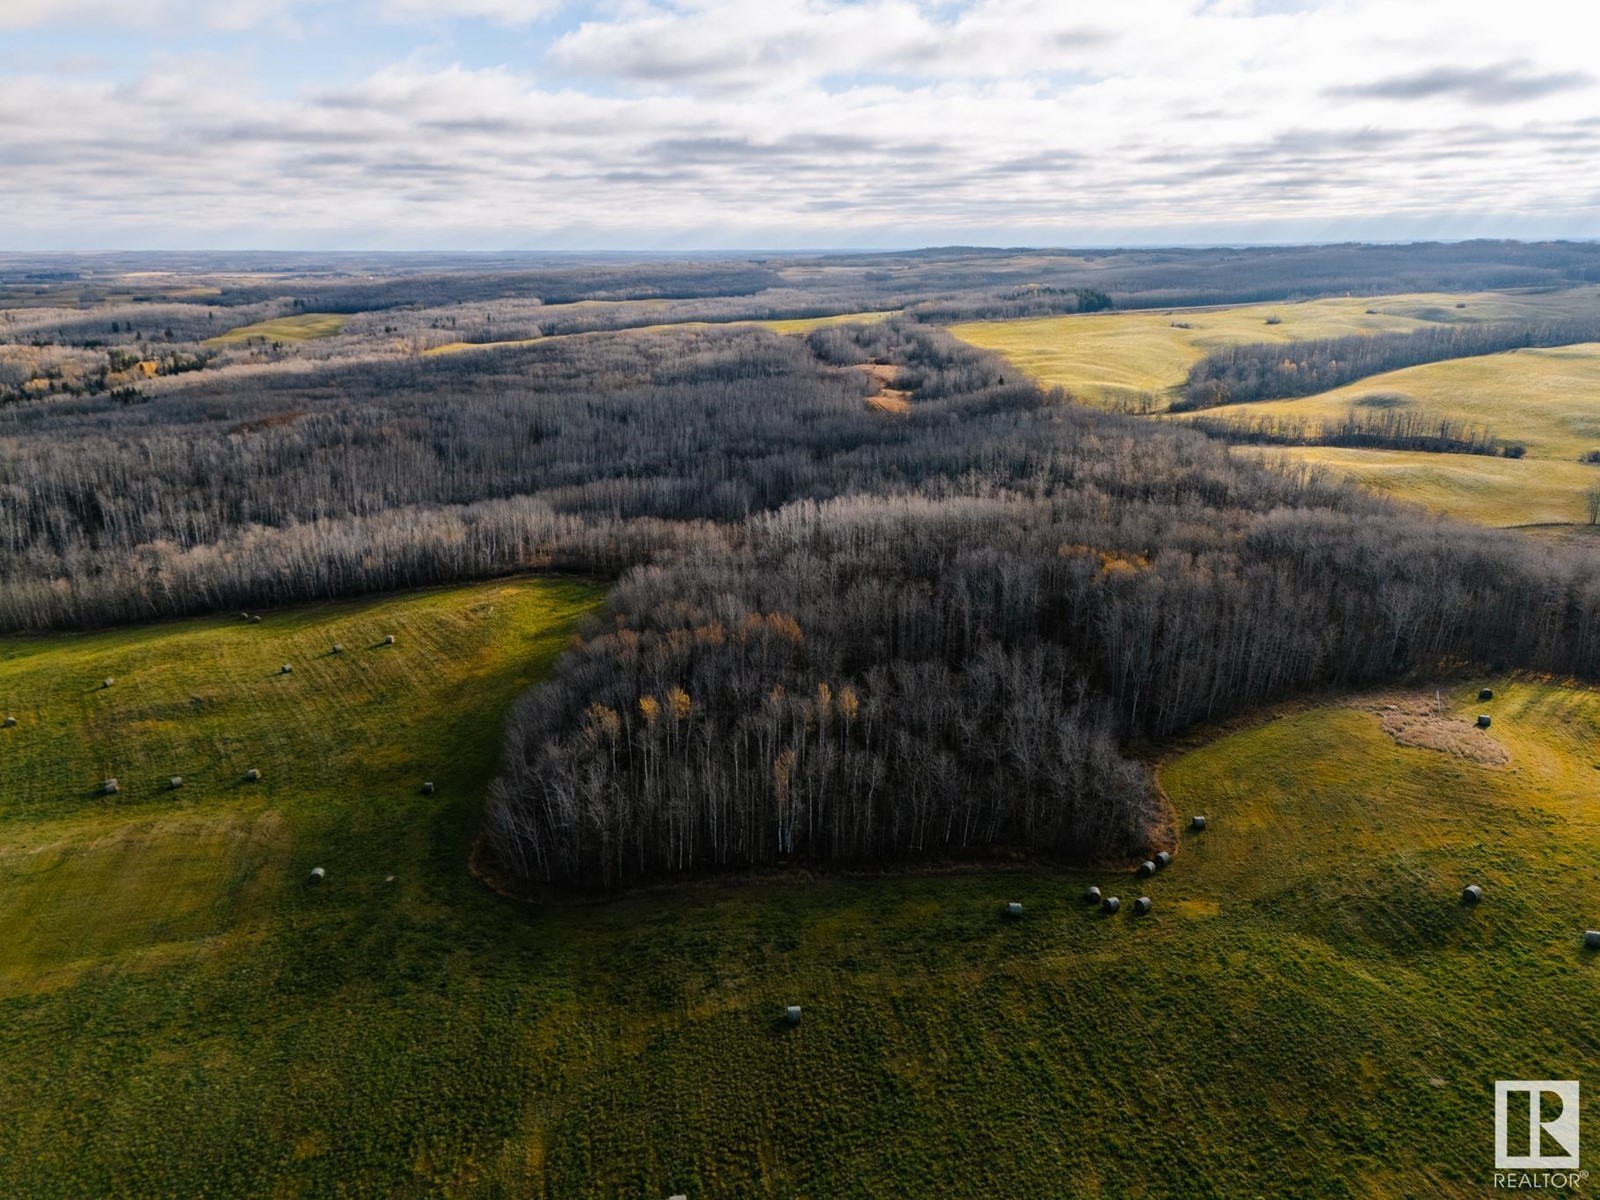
9 243 1600 886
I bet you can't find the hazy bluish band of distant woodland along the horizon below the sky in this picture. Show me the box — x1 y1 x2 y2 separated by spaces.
18 242 1600 344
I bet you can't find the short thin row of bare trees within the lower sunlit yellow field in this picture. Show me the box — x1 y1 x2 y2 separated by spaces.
1187 408 1525 458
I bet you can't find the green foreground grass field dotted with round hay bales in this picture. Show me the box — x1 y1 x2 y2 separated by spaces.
0 581 1600 1198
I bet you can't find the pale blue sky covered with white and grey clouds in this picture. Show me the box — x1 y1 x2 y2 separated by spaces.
0 0 1600 250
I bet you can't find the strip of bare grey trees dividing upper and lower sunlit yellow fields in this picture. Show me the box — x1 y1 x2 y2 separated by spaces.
1173 318 1600 413
